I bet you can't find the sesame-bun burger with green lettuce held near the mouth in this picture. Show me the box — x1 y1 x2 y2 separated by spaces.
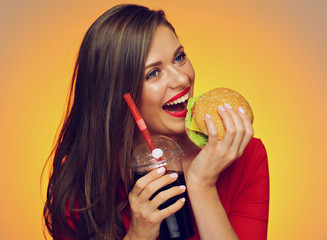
185 88 253 148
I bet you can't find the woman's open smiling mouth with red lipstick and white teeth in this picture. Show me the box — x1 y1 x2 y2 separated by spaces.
162 92 190 117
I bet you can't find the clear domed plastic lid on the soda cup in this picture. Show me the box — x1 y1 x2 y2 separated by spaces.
131 135 184 168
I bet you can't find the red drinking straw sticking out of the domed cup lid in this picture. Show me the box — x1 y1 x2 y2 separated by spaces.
124 93 161 153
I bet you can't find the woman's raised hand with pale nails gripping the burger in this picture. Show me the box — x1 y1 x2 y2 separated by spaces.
187 104 253 187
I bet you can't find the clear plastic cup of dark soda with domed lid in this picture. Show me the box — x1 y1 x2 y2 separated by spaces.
131 135 194 240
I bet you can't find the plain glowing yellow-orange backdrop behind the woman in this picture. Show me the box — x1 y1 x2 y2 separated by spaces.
0 0 327 240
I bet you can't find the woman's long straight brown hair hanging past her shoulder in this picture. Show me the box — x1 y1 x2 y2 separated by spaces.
43 4 174 240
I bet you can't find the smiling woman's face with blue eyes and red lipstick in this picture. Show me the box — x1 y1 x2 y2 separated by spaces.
139 26 195 135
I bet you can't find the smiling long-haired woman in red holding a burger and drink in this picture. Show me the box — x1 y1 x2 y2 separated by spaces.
44 5 269 240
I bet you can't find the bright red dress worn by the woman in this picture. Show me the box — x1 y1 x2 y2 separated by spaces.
122 138 269 240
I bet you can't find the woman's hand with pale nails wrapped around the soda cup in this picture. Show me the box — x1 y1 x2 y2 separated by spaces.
125 167 185 240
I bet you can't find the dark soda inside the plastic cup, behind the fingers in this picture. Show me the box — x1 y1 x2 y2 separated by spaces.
135 171 194 240
